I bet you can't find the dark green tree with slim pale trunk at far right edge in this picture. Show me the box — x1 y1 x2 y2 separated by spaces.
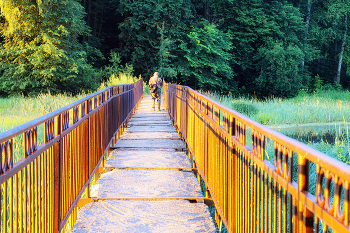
308 0 349 87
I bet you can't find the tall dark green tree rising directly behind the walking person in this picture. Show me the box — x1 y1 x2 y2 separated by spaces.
117 0 192 76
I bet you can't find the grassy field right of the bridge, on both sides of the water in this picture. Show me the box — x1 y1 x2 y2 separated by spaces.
203 90 350 167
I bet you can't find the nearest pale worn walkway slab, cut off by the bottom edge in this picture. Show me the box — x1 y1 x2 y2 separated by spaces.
73 200 215 233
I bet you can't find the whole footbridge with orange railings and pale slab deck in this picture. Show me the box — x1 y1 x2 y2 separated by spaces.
0 80 350 233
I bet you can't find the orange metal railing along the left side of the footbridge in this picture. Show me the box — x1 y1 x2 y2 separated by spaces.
0 80 143 232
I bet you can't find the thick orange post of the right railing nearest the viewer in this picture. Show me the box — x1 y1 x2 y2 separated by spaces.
298 154 313 233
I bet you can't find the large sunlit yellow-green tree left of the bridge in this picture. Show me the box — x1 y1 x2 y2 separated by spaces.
0 0 96 95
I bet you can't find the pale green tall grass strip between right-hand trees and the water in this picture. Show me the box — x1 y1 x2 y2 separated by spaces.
203 90 350 125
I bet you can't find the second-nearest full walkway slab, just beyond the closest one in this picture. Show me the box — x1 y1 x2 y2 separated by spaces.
91 169 203 198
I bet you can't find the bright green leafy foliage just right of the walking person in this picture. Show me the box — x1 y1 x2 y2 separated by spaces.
180 21 236 93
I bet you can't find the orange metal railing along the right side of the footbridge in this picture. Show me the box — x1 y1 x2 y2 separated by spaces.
164 84 350 233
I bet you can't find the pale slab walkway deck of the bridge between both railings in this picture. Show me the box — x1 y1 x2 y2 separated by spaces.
72 96 215 232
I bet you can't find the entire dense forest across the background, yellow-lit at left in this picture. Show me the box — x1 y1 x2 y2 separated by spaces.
0 0 350 97
